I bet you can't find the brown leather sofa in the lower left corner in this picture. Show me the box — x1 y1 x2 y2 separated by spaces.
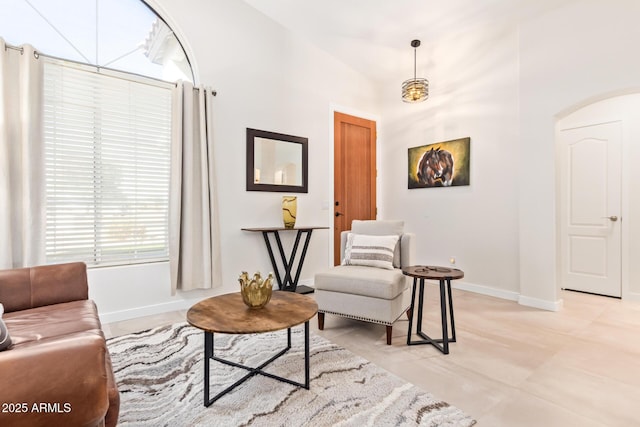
0 263 120 427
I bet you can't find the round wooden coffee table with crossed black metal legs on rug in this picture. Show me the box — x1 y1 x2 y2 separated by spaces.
187 291 318 406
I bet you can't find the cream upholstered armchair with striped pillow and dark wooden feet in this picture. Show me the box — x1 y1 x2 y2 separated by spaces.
314 220 415 345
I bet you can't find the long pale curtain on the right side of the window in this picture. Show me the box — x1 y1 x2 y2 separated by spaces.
169 82 222 294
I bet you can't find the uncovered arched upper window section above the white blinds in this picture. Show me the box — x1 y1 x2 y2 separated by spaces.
0 0 194 82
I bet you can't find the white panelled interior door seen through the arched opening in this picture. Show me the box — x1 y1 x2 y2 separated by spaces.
559 122 622 297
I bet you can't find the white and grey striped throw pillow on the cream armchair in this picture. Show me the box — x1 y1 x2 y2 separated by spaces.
342 233 399 270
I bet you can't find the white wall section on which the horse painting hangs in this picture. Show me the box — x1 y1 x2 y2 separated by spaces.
381 27 519 299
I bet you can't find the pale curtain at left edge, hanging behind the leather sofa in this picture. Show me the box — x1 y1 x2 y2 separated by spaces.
0 39 45 269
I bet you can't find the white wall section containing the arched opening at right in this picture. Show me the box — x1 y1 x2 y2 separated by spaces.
518 0 640 305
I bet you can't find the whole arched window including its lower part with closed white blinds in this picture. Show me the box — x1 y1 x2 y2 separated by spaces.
0 0 193 266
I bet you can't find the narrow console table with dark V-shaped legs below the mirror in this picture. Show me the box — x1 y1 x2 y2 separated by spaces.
242 226 329 294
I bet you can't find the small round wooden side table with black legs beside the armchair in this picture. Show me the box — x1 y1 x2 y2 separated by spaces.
402 265 464 354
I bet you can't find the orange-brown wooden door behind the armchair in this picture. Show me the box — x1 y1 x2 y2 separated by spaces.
333 112 376 265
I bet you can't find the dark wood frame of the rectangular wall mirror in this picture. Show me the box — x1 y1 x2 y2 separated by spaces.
247 128 309 193
